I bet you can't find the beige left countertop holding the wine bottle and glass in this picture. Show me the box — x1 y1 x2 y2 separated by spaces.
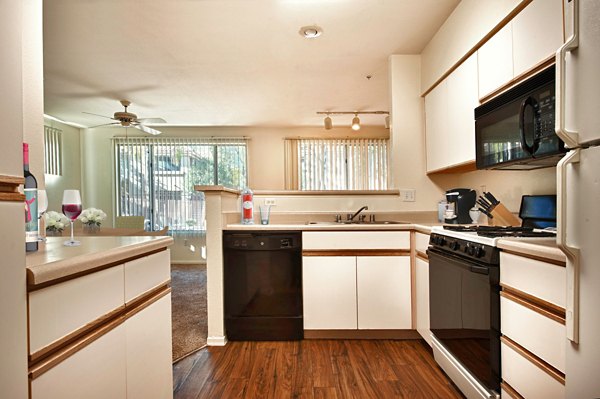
26 236 173 289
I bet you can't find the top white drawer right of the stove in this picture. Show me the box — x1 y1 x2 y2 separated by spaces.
500 252 566 308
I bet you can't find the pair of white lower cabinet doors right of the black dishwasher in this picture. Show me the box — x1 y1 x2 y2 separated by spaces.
302 256 411 330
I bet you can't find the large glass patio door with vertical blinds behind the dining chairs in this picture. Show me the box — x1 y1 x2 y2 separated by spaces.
113 138 247 235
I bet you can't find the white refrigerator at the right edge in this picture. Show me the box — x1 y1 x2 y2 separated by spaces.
556 0 600 398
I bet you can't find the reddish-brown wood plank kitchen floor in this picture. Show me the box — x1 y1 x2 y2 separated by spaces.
173 340 463 399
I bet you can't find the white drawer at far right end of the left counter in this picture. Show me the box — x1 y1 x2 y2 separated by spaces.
125 249 171 302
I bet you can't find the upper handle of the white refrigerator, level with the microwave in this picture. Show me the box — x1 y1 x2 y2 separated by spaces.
554 0 579 148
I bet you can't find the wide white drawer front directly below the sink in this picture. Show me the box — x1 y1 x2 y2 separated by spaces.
302 231 410 250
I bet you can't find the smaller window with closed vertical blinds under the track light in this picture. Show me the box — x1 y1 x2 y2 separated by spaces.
285 139 389 190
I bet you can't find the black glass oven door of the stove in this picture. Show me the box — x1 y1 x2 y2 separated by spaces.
427 248 500 392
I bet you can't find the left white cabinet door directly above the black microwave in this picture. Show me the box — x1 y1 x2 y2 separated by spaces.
477 23 514 98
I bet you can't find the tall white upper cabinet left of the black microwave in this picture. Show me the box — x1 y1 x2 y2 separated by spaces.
425 54 479 172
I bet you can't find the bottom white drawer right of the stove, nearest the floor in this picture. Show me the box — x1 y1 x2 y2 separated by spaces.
501 342 565 399
